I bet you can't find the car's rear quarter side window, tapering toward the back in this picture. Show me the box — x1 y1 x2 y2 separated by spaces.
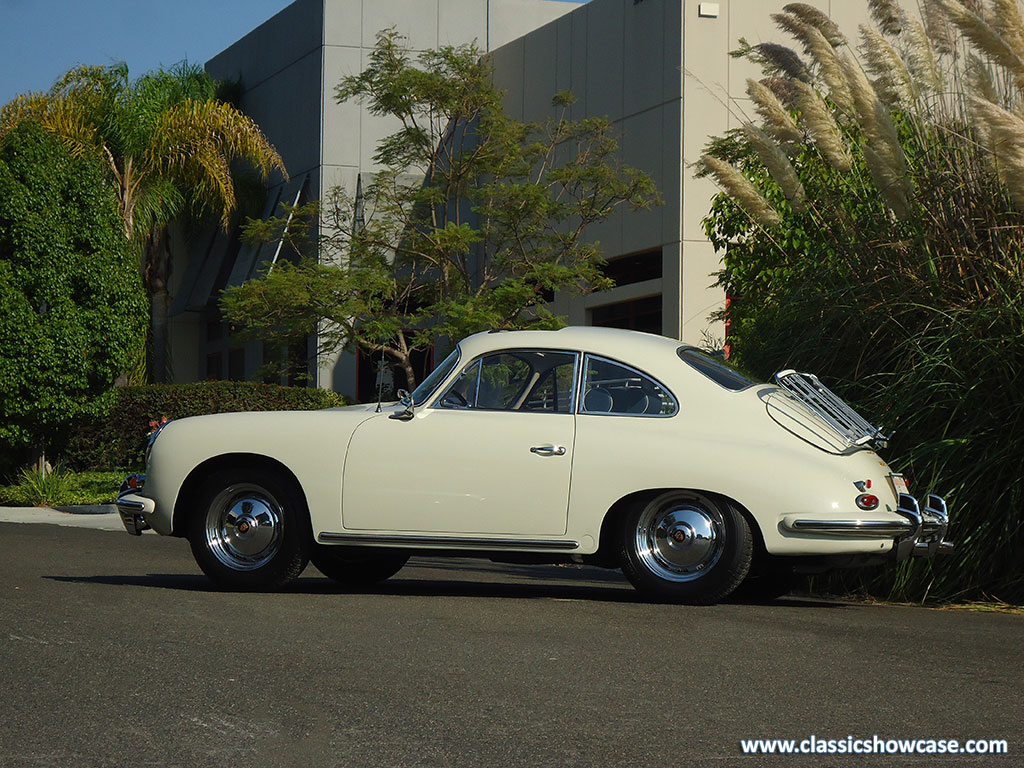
580 355 677 416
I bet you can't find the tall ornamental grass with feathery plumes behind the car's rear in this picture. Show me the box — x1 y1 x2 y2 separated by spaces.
699 0 1024 603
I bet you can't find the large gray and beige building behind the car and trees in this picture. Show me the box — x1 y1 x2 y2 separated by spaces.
173 0 867 394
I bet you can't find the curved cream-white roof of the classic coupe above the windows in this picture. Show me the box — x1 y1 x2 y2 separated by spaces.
460 326 684 364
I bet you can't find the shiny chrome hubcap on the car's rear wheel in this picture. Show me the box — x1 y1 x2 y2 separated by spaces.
636 495 725 582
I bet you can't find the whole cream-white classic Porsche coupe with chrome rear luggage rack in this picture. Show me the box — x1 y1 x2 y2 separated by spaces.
117 328 952 603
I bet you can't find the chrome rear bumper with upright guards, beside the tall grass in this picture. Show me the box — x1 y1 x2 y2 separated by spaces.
782 494 953 560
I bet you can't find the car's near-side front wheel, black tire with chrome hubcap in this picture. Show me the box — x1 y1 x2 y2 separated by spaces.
188 469 312 591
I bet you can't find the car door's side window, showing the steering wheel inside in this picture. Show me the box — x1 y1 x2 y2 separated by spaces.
438 349 577 414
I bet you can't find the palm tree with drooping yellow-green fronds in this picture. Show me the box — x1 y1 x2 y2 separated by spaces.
0 62 287 382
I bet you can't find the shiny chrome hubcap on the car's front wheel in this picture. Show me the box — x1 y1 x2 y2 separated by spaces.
206 484 284 570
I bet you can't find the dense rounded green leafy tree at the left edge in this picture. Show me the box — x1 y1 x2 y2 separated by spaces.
0 121 145 468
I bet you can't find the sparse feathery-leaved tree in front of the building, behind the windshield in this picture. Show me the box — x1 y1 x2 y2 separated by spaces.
222 31 657 386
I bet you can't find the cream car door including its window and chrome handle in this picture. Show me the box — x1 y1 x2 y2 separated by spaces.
342 350 579 537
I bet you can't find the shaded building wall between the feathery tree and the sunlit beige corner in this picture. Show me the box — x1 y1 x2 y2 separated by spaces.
493 0 683 337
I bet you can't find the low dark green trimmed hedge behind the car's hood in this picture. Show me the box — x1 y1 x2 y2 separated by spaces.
60 381 346 471
